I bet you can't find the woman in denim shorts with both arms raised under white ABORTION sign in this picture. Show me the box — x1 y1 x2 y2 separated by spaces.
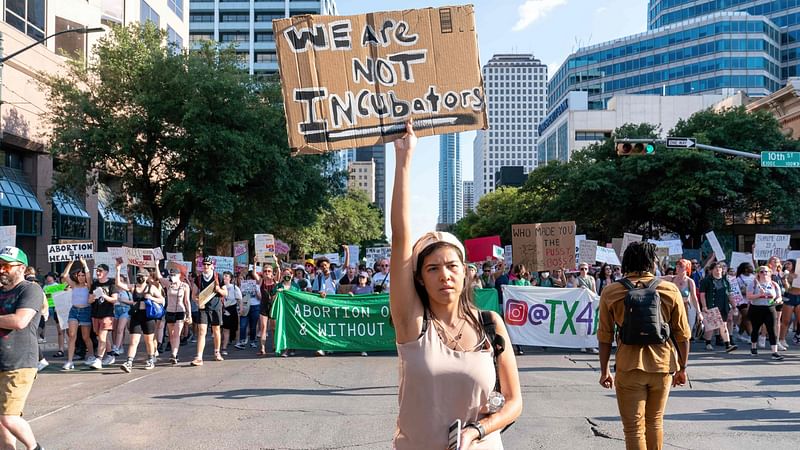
61 258 95 370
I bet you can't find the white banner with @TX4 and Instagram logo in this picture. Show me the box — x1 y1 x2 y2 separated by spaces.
503 284 596 348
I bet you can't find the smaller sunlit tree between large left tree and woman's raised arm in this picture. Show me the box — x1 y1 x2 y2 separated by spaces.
286 190 385 259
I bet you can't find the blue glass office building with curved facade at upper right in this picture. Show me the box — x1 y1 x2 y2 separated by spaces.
549 0 800 110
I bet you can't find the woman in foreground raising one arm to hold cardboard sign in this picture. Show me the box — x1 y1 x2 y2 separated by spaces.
389 123 522 450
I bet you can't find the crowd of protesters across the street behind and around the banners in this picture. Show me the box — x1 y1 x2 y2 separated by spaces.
27 246 800 372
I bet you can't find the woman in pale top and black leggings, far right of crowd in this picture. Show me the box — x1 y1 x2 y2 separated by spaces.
747 266 783 361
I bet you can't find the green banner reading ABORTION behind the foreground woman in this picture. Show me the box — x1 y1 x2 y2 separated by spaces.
272 289 500 352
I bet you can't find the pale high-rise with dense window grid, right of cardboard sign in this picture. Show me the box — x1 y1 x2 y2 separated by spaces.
473 54 547 201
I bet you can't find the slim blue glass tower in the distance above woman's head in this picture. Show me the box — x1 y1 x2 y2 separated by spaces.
439 133 464 225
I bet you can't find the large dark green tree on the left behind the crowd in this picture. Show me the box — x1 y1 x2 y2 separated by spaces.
43 23 327 250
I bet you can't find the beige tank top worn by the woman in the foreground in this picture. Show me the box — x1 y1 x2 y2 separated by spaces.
393 314 503 450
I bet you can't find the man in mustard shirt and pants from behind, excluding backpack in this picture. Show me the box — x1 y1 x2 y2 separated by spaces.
597 242 691 450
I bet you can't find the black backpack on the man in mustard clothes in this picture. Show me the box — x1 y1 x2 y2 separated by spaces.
619 278 670 345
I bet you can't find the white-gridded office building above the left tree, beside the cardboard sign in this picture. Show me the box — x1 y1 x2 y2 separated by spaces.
189 0 337 75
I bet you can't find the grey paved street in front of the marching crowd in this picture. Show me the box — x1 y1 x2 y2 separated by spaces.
26 344 800 450
